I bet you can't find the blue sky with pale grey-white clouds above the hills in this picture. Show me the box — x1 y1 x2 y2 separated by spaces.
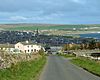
0 0 100 24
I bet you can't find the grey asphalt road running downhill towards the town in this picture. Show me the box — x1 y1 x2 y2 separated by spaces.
39 55 100 80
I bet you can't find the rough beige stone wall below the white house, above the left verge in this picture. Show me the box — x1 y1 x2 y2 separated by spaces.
0 51 41 69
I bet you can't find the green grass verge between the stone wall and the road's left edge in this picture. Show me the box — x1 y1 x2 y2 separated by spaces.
0 57 46 80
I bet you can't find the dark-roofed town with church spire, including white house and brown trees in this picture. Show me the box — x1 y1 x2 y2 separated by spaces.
0 29 100 56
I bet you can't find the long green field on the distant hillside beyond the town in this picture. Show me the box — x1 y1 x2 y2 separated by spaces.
5 24 100 30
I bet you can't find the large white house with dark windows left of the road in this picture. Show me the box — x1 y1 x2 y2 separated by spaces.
15 41 42 53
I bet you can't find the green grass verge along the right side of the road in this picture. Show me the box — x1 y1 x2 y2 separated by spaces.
71 58 100 76
